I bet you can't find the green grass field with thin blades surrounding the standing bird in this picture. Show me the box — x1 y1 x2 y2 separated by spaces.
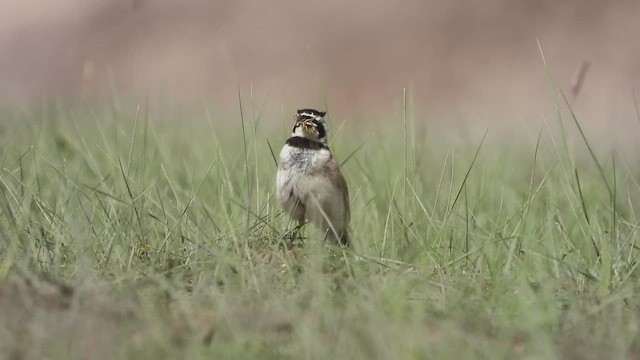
0 97 640 359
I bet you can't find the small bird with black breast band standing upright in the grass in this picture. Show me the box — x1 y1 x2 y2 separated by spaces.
276 109 351 246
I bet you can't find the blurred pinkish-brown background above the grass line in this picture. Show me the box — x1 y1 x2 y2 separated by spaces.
0 0 640 126
